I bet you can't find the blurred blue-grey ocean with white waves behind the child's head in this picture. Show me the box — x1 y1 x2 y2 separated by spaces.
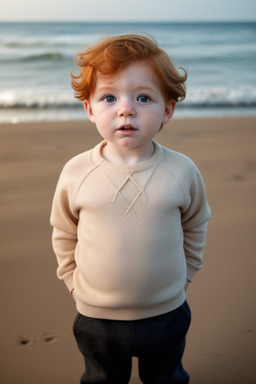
0 22 256 123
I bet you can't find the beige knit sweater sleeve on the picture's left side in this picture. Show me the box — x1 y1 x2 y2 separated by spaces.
50 161 79 292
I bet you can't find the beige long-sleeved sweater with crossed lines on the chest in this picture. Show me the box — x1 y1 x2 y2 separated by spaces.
51 142 210 320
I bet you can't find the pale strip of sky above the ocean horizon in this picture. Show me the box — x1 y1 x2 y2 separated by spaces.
0 0 256 21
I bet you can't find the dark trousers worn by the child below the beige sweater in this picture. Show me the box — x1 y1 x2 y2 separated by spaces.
73 301 191 384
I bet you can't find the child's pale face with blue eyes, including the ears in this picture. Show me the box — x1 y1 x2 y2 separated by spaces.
84 62 175 162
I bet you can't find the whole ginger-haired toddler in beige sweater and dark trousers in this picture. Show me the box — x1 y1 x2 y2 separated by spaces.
51 35 210 384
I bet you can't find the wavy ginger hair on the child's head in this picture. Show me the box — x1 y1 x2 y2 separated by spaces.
71 35 187 102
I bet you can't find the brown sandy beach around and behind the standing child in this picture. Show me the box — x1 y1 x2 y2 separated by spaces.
0 117 256 384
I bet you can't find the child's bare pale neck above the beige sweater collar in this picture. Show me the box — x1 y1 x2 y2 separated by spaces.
102 141 155 165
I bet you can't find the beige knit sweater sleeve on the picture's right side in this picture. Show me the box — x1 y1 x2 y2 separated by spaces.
181 163 211 281
